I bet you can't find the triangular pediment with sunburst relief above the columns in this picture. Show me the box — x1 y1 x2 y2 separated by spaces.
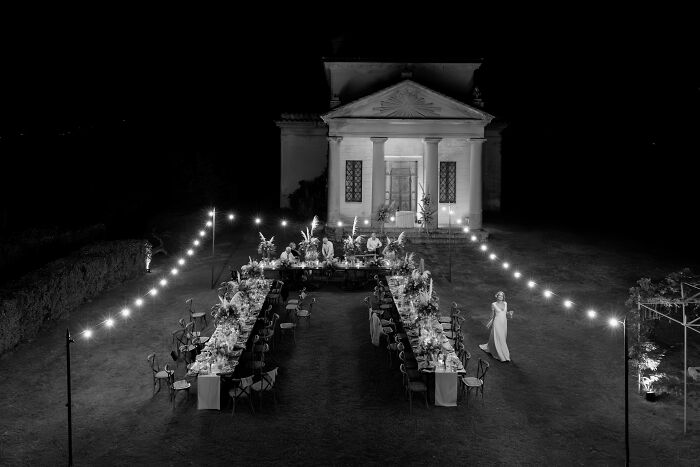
321 80 493 124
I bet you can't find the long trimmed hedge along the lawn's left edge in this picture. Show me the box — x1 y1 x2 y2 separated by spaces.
0 240 147 354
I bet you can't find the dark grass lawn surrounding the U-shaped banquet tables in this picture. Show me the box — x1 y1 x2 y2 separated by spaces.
0 220 700 465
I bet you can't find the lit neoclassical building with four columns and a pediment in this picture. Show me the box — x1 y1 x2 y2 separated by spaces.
277 60 504 229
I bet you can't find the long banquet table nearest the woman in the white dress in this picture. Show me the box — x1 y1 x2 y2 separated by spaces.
386 276 466 406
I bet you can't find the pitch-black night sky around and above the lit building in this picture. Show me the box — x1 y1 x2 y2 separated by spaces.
0 12 700 249
